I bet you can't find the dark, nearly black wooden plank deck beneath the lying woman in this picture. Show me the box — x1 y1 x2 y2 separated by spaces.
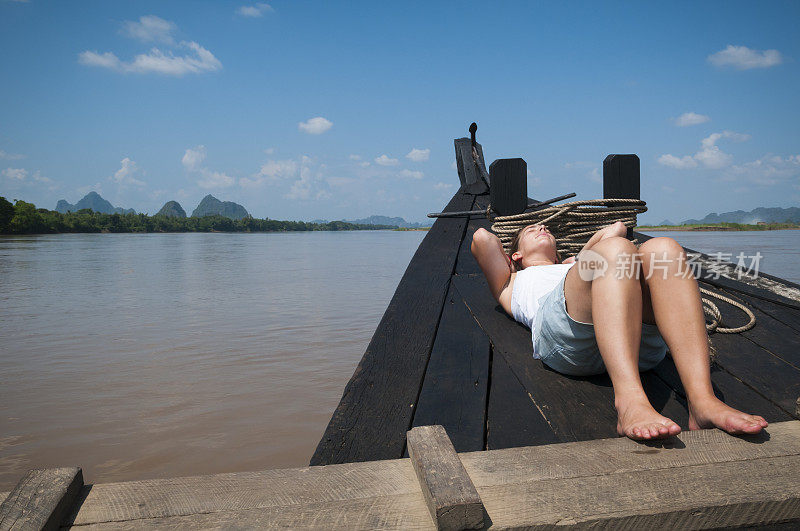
311 187 800 465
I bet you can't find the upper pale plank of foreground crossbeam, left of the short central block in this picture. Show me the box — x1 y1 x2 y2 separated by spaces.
70 459 424 526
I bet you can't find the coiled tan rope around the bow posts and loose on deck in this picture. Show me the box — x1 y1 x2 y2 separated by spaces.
486 199 756 334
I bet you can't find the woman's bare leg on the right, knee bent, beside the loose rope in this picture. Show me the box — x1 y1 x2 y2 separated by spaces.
639 237 767 433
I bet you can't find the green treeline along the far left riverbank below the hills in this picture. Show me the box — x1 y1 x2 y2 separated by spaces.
0 197 396 234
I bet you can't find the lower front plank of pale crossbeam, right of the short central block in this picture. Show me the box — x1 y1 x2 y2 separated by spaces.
478 455 800 529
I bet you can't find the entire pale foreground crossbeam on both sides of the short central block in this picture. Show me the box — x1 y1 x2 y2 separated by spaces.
67 421 800 529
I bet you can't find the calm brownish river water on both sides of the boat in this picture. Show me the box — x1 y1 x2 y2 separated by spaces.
0 231 800 491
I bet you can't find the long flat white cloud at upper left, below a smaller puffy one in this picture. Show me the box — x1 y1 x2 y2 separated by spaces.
78 34 222 76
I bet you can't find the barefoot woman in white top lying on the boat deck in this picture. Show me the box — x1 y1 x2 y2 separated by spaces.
471 222 767 440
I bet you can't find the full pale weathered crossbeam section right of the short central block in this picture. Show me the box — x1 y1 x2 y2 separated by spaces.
459 421 800 529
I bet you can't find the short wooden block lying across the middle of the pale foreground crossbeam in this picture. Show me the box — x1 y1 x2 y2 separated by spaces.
408 426 483 530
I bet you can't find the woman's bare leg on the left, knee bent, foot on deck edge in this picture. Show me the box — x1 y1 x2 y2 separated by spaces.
564 238 681 440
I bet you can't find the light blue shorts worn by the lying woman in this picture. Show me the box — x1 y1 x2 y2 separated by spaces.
534 276 667 376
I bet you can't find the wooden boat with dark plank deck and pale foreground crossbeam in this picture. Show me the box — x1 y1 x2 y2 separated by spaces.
0 134 800 529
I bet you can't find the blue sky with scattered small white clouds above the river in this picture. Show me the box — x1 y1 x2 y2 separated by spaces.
0 0 800 223
